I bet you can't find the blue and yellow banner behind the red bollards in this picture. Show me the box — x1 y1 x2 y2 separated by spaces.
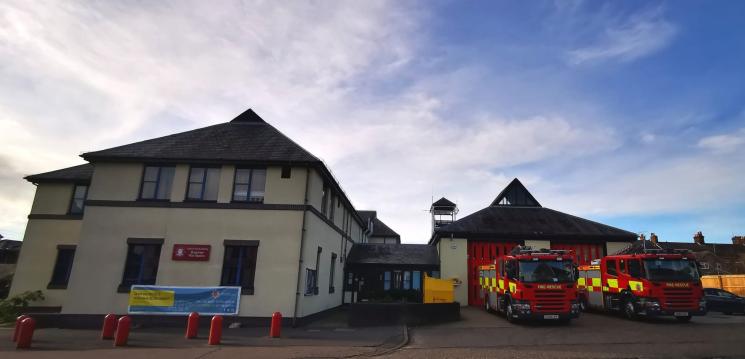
127 285 241 315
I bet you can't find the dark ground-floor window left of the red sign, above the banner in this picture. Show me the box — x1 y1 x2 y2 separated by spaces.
119 239 163 292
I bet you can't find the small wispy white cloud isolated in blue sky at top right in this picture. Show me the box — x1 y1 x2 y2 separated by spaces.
567 8 677 65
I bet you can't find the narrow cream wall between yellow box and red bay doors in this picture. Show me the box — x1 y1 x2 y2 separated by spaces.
438 238 468 306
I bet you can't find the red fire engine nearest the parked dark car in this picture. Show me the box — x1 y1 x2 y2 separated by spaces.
577 247 706 321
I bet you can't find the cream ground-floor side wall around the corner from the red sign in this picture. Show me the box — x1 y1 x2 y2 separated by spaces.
298 212 351 317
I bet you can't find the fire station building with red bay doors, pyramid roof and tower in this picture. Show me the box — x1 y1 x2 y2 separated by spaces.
429 179 637 306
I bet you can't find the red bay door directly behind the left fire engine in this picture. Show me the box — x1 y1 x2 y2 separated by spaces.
464 241 520 307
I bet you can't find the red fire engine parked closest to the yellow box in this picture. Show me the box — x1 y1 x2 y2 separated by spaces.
479 246 580 322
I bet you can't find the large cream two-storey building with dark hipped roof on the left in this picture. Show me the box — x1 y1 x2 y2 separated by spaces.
11 109 369 324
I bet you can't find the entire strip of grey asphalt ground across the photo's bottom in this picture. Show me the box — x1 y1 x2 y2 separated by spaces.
0 308 745 359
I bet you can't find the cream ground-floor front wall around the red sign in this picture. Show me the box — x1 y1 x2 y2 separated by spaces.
63 206 302 317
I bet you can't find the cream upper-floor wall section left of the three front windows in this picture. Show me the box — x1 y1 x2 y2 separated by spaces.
88 163 142 201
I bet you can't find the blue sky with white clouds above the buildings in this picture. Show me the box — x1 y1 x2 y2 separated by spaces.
0 0 745 243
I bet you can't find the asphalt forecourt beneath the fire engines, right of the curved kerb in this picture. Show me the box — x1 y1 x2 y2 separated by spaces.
390 308 745 359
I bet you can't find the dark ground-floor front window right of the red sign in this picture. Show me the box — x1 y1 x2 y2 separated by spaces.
220 241 259 295
